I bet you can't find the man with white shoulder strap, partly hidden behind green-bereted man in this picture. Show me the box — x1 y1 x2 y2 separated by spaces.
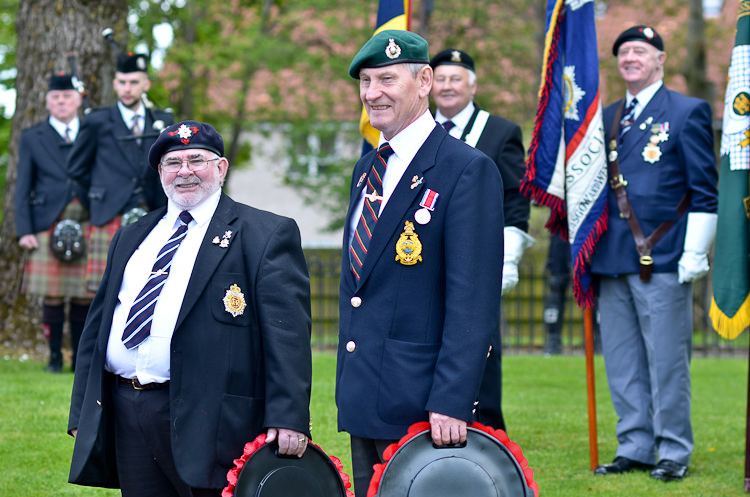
430 48 534 429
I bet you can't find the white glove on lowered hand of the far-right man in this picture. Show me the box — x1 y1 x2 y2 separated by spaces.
677 212 718 283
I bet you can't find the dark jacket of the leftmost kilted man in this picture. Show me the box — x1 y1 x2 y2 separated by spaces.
13 120 88 237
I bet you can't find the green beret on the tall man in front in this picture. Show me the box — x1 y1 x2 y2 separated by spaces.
349 29 430 79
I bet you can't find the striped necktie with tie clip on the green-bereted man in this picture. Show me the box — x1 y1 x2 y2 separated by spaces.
349 142 393 279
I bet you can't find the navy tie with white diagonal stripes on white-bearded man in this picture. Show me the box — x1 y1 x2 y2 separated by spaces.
122 211 193 349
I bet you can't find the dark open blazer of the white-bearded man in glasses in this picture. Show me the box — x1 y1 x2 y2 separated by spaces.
68 195 311 488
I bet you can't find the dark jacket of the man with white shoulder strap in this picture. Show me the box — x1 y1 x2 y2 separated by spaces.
474 108 530 231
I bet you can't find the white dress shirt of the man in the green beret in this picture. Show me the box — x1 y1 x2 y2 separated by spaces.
349 110 436 245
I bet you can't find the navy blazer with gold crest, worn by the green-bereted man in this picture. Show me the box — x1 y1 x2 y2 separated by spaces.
336 126 503 439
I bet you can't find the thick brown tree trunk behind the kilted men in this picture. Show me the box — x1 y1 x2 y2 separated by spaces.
0 0 128 352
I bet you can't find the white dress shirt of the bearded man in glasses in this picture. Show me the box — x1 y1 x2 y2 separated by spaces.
105 191 221 383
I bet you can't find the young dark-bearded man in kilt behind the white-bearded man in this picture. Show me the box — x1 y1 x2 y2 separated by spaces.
68 53 174 293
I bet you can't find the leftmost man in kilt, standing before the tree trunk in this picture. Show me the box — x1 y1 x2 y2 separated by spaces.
14 74 93 373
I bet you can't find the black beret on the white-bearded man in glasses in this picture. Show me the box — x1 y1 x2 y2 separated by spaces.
148 121 224 169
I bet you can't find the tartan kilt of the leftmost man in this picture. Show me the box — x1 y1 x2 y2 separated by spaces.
21 200 93 299
